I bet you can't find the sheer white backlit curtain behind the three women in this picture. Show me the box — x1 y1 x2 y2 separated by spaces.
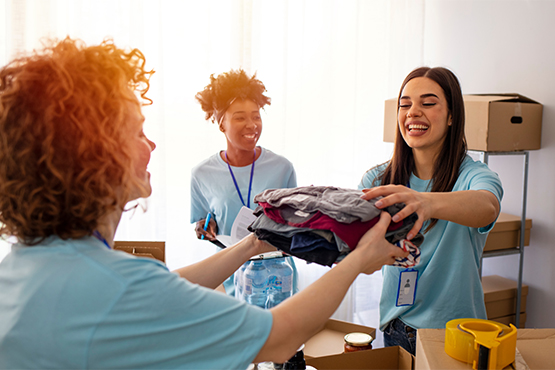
0 0 425 327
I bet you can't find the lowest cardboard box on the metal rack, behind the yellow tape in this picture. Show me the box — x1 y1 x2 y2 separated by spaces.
482 275 528 318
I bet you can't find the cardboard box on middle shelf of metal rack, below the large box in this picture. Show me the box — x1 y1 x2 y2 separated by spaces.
484 212 532 252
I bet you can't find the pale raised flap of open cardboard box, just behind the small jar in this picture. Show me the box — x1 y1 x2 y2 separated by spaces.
303 319 376 359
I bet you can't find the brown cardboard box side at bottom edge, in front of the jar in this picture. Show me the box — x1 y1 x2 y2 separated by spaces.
306 346 414 370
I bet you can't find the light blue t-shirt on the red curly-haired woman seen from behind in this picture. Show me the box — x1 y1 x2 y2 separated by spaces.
0 237 272 370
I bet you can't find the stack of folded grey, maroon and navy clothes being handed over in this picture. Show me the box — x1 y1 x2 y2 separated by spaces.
249 186 424 267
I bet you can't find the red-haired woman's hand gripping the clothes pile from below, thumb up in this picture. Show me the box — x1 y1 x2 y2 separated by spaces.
350 211 409 274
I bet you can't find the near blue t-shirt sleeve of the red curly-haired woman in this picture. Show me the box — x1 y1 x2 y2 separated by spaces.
89 260 272 369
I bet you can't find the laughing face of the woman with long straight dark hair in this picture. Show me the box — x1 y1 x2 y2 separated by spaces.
397 77 451 155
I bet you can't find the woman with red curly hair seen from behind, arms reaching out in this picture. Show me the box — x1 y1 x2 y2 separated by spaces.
0 38 403 369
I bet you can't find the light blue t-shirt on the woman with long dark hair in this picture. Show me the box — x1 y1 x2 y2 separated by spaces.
358 156 503 330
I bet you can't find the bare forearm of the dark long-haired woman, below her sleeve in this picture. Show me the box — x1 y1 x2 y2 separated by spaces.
425 190 499 228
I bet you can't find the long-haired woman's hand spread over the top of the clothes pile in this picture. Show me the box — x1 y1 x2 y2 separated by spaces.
362 185 432 240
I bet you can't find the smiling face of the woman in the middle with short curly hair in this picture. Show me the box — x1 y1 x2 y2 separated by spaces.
221 99 262 152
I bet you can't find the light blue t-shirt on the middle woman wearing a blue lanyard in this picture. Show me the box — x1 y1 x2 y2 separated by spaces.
191 148 297 235
